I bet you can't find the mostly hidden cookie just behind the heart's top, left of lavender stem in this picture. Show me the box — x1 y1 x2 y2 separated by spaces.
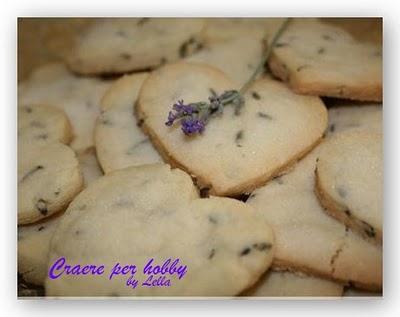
185 37 263 85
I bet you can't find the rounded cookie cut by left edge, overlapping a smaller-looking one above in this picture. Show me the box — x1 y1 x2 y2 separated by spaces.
18 140 83 224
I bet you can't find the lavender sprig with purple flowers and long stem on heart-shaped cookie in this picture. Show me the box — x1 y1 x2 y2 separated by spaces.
165 18 290 135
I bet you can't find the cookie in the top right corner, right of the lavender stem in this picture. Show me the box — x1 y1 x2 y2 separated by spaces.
269 19 382 101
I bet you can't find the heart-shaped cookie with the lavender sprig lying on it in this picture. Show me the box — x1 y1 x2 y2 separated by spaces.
136 63 327 196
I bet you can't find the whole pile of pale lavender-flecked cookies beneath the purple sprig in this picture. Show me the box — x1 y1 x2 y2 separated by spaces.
18 18 383 297
